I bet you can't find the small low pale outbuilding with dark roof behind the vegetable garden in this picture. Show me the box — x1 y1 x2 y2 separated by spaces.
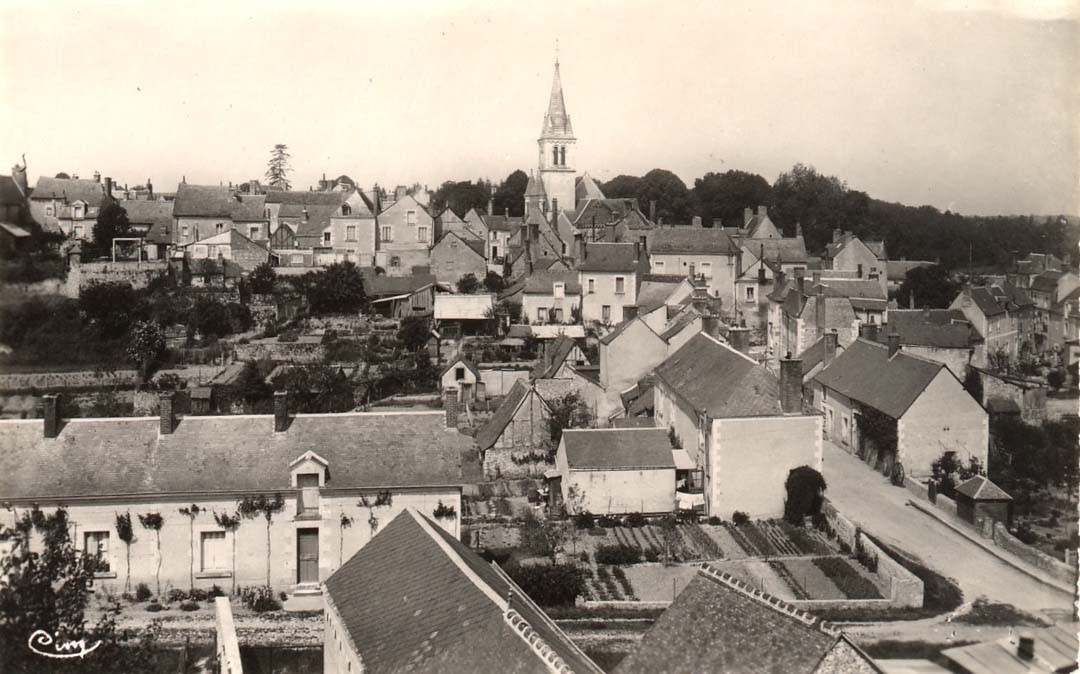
552 428 675 515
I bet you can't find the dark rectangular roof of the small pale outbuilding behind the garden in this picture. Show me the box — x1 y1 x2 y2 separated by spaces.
562 428 675 470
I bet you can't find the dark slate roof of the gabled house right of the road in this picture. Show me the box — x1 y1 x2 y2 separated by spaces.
814 338 945 419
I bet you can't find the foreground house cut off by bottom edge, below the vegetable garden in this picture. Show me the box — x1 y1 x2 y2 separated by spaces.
615 563 881 674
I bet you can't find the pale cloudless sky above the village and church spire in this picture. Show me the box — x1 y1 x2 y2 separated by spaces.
0 0 1080 215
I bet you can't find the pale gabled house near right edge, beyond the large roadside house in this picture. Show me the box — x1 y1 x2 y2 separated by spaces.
948 283 1035 360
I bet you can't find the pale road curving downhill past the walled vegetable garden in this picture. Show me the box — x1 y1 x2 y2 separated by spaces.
824 441 1072 615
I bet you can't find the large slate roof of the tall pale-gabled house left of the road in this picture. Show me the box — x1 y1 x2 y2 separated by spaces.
656 333 781 419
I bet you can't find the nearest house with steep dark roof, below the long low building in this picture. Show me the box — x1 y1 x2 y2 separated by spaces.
322 509 603 674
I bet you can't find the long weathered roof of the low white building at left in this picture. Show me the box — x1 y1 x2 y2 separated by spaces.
0 412 477 500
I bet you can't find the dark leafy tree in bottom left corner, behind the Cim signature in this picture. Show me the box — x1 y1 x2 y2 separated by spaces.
0 507 160 674
